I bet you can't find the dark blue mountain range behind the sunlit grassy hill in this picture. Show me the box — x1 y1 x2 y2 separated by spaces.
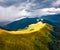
4 14 60 30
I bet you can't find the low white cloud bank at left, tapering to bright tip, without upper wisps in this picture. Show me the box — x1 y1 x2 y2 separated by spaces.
0 6 30 21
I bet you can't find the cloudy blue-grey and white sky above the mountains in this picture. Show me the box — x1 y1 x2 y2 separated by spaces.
0 0 60 22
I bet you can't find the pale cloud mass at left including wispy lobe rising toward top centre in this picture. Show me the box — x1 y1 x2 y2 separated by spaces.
0 2 35 21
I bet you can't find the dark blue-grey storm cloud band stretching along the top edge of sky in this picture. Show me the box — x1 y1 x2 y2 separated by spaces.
0 0 57 9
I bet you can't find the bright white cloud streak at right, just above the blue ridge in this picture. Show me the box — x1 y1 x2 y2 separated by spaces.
32 8 60 16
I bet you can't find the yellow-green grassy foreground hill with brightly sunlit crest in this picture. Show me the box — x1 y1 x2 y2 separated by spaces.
0 22 60 50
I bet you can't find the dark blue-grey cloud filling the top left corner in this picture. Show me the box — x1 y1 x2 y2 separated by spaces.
0 0 26 7
